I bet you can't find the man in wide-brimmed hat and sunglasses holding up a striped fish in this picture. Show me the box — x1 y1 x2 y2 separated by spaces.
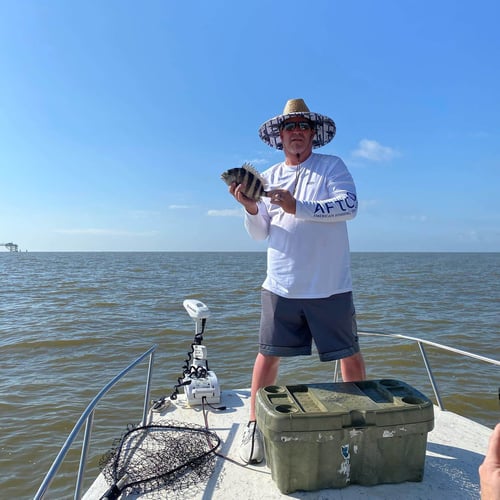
229 99 365 463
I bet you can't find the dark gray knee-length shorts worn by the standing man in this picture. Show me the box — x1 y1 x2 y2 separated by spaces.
259 290 359 361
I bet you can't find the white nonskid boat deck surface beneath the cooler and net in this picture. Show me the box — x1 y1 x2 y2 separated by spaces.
84 390 492 500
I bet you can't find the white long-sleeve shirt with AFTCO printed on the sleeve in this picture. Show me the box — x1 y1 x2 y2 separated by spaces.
245 153 358 298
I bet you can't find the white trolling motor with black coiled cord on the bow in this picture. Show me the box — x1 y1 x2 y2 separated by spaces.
170 299 220 406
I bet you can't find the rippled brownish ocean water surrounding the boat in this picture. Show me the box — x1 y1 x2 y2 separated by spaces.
0 252 500 499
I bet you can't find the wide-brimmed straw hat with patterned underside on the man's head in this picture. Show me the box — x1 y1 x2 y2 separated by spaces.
259 99 336 149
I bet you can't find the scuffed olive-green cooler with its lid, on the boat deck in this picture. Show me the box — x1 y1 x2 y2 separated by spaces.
256 379 434 493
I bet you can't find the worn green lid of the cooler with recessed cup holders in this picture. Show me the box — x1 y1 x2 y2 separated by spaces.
257 379 434 431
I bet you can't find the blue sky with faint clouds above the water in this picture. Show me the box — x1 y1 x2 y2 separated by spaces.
0 0 500 252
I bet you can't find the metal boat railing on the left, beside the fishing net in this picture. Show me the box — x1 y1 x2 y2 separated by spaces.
34 344 157 500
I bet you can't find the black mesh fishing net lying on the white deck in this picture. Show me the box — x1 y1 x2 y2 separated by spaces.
100 421 220 500
